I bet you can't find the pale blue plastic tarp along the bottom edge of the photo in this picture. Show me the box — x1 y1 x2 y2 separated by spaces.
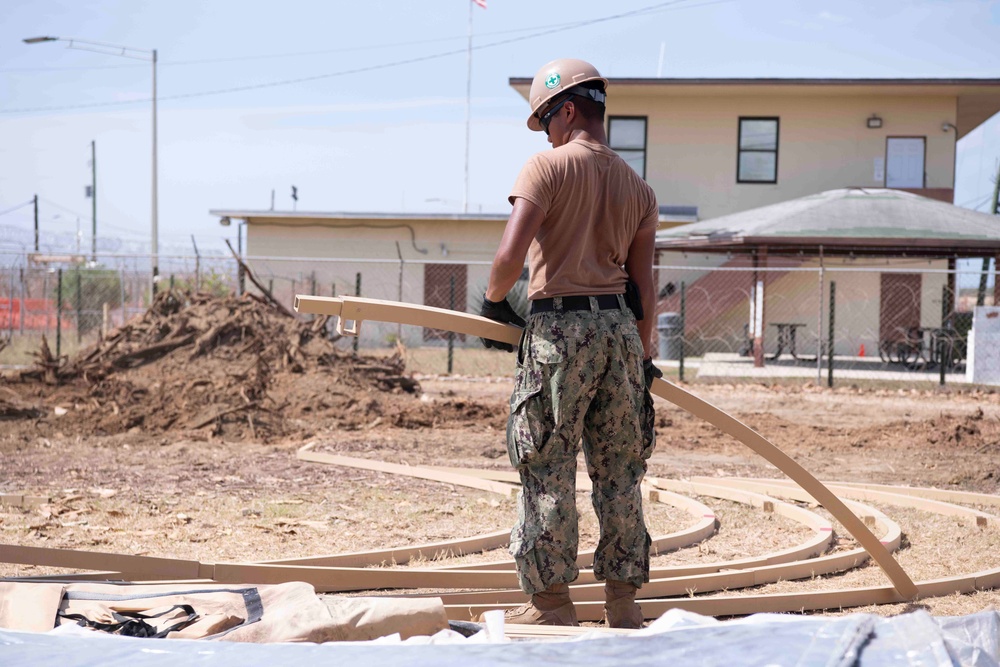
0 610 1000 667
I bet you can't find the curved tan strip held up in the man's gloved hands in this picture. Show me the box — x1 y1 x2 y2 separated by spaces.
294 295 917 599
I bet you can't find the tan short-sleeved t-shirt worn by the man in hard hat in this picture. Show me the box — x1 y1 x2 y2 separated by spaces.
509 140 659 299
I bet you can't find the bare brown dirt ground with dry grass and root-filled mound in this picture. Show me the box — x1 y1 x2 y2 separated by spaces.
0 296 1000 614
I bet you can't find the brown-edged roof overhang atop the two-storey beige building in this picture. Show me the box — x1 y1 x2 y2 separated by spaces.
509 77 1000 138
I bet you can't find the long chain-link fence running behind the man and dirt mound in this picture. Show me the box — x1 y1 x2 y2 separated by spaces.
0 249 995 385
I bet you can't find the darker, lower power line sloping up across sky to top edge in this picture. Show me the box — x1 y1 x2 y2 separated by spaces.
0 0 735 114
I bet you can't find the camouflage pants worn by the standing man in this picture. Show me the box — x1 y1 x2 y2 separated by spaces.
507 304 654 594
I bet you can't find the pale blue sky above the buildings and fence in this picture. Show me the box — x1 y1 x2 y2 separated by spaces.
0 0 1000 254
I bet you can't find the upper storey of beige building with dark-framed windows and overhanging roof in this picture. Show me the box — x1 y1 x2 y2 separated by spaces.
510 78 1000 220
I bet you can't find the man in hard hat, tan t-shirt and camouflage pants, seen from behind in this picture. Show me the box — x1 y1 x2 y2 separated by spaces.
481 59 659 628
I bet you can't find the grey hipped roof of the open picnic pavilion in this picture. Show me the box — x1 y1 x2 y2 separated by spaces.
656 188 1000 256
